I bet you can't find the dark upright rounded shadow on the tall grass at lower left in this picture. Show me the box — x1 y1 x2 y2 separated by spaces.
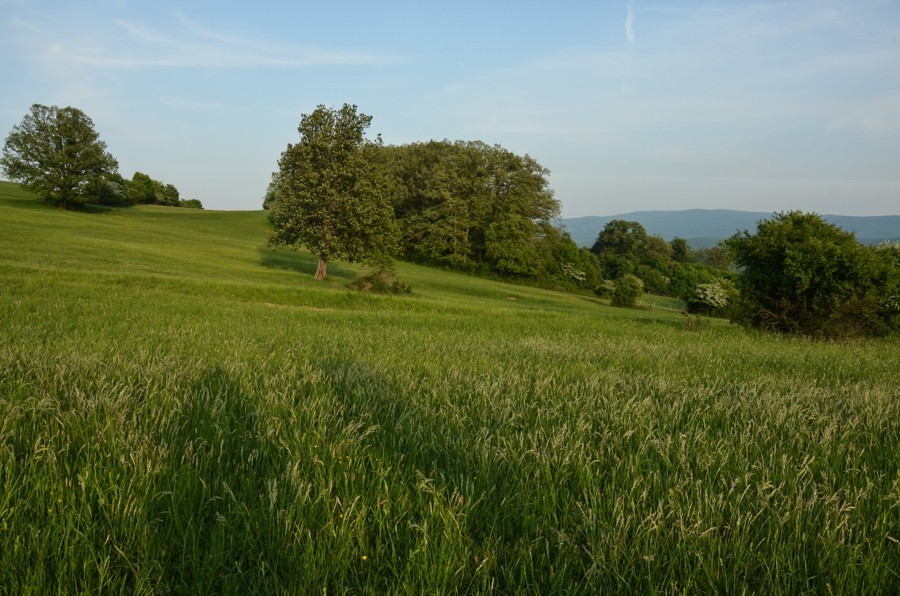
144 366 292 594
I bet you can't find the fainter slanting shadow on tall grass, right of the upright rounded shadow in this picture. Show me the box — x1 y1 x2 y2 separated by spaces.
321 357 587 593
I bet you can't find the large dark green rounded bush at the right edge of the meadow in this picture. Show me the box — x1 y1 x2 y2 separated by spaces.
726 211 900 338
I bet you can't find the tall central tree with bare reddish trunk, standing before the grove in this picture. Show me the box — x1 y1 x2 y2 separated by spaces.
270 104 397 279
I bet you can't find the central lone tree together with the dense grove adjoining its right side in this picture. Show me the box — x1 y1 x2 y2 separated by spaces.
263 105 599 288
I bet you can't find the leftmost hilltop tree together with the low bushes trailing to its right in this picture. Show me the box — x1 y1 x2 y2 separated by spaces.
0 104 203 209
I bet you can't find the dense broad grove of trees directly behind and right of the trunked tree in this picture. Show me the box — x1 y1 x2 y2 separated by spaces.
383 141 559 279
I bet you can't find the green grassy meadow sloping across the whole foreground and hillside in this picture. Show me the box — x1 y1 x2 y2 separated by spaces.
0 183 900 594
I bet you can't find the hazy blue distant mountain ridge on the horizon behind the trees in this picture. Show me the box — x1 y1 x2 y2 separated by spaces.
561 209 900 249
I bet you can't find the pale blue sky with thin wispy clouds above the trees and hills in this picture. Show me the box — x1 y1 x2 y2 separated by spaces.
0 0 900 217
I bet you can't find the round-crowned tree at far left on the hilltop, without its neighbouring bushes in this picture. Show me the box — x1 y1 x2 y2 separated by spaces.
0 104 119 209
